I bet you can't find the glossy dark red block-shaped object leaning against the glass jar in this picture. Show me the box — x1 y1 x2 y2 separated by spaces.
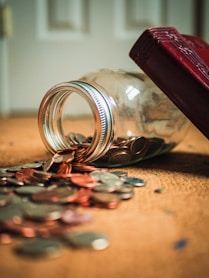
129 27 209 139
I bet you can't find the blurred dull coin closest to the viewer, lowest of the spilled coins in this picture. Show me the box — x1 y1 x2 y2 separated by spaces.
16 238 62 257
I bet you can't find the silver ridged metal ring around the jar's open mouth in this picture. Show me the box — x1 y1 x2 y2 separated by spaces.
38 81 114 162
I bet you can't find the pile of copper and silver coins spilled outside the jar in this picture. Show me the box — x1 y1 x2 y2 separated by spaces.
0 152 146 257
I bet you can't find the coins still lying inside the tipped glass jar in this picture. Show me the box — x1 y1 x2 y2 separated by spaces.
66 132 175 167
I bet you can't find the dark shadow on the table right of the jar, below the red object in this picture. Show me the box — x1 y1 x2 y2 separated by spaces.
135 152 209 177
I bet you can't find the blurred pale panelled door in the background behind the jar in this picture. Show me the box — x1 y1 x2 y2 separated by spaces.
0 0 209 115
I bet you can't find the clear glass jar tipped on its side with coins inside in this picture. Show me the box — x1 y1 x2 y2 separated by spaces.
38 69 188 167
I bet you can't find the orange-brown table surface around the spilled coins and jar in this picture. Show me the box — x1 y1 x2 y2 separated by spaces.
0 117 209 278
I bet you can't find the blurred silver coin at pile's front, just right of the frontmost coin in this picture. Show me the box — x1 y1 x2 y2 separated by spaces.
64 231 109 250
